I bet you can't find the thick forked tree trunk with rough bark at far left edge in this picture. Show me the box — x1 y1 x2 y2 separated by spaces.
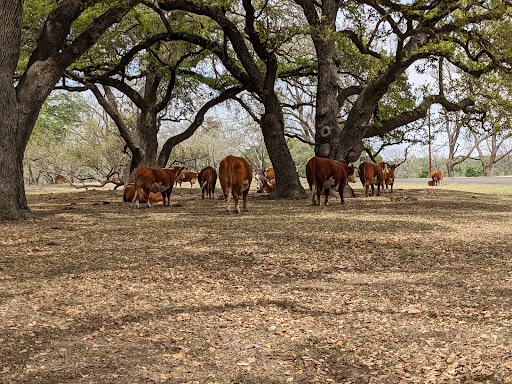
0 0 139 220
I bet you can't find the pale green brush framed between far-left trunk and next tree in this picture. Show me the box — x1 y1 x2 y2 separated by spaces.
25 92 127 184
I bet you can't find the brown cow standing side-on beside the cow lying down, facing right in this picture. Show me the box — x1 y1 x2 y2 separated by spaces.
132 167 184 208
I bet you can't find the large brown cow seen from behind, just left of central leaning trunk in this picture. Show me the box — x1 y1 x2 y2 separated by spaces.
219 155 252 213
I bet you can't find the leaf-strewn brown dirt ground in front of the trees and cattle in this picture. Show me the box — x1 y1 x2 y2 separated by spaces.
0 186 512 384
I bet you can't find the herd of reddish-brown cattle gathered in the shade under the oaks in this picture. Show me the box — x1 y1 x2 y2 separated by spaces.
123 156 443 213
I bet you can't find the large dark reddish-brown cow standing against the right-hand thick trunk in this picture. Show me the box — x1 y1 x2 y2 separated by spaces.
306 156 355 205
